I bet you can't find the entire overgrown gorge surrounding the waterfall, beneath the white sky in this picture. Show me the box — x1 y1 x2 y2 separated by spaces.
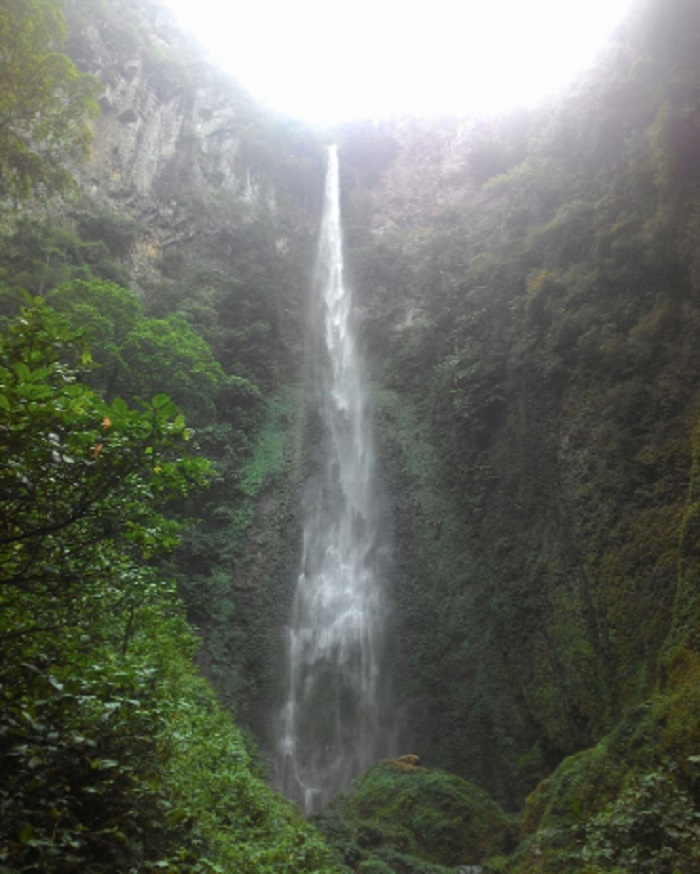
0 0 700 874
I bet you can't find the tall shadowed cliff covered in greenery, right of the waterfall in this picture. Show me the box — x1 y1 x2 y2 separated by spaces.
338 0 700 801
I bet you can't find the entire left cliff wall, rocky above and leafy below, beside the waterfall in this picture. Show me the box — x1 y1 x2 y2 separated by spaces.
0 0 322 733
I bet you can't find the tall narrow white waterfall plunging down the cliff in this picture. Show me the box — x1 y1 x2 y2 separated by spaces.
278 146 384 813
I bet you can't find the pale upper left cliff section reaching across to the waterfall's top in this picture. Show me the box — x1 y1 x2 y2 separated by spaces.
68 0 322 296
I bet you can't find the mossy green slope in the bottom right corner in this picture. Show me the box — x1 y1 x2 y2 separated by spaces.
506 663 700 874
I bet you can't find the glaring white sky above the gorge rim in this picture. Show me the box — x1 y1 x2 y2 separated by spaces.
165 0 631 125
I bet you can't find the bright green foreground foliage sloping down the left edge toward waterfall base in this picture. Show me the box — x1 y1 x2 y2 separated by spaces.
0 300 340 872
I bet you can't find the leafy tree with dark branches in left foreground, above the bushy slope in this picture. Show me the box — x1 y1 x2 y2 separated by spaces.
0 301 208 634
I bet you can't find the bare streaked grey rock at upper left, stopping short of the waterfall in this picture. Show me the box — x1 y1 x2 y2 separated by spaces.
68 3 275 224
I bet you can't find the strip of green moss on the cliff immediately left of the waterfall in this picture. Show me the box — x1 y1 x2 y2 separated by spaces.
183 385 304 739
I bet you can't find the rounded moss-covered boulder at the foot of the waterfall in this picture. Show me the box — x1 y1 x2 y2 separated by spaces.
317 760 512 872
